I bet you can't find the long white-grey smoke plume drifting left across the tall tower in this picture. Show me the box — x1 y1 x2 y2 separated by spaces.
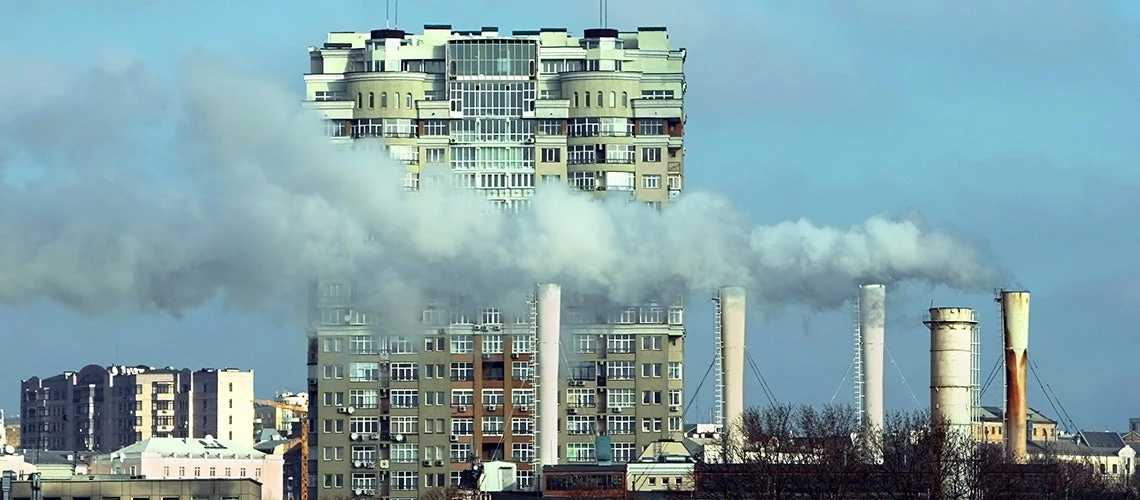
0 56 994 313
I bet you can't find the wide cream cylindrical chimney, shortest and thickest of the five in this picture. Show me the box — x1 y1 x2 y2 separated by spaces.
923 308 977 437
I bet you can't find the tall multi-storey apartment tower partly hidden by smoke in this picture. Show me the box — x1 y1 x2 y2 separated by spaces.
304 25 685 499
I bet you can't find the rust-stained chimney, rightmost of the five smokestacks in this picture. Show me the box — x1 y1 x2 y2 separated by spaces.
998 290 1029 464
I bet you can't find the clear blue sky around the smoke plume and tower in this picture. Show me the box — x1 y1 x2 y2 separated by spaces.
0 0 1140 429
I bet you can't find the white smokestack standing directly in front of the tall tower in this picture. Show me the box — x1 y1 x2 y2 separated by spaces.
536 284 562 469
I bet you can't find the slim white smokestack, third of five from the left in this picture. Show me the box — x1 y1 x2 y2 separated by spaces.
858 285 887 461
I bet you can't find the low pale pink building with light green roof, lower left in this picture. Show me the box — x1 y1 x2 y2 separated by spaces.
90 436 284 500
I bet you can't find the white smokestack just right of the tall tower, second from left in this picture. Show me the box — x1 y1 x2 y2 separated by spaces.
717 287 746 461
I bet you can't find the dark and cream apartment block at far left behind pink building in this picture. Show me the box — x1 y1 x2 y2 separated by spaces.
19 364 253 452
